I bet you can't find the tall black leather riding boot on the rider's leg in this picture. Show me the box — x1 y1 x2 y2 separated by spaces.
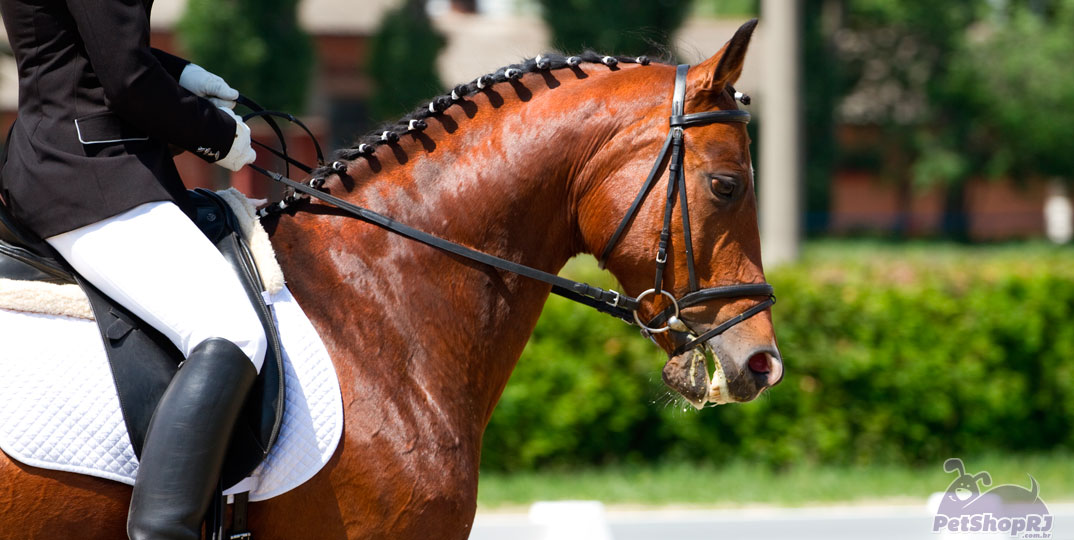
127 338 258 540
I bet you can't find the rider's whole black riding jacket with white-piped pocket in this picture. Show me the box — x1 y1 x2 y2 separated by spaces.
0 0 235 237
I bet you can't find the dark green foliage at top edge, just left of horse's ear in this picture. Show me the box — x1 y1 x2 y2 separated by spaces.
540 0 693 56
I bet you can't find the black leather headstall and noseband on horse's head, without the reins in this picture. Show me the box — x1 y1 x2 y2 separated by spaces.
599 64 775 355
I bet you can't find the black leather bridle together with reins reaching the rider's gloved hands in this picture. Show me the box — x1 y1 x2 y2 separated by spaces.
240 64 775 356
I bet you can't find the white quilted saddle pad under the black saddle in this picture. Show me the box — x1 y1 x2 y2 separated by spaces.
0 288 343 500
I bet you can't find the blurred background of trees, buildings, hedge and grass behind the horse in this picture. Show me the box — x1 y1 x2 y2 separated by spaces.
0 0 1074 538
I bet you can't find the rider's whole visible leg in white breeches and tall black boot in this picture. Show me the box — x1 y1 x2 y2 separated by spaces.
46 203 267 540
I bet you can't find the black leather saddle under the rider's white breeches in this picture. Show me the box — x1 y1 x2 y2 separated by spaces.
0 189 285 487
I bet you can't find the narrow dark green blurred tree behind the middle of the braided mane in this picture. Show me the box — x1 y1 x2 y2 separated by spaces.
367 0 446 121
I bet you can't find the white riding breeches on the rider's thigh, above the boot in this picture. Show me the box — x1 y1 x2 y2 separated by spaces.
45 202 267 371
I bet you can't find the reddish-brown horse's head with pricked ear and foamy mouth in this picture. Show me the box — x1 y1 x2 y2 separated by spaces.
578 20 783 407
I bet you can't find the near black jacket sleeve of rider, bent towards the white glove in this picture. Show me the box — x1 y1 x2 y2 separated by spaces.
67 0 235 161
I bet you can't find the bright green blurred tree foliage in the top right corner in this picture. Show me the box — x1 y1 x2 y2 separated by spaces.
950 0 1074 181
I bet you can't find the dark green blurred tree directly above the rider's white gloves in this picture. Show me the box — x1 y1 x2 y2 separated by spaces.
178 0 314 113
